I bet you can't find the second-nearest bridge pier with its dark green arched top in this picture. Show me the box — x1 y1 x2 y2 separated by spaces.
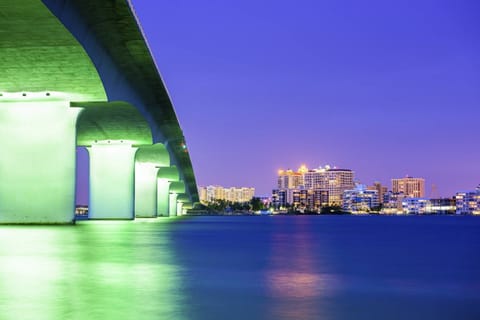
74 101 152 219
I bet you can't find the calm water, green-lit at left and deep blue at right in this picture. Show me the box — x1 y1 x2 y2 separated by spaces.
0 216 480 320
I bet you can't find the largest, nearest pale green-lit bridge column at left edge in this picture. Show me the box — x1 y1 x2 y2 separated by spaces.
0 99 81 224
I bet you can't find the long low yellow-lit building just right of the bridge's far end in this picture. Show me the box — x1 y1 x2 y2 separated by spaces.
199 185 255 203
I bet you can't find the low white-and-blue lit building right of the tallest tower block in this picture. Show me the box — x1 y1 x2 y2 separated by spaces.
342 184 379 213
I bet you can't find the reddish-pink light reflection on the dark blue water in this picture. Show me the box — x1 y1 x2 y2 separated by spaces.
266 217 335 319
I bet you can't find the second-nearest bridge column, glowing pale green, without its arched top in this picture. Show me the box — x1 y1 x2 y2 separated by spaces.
87 142 137 219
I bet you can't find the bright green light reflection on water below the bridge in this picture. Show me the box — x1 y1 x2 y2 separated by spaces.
0 220 185 320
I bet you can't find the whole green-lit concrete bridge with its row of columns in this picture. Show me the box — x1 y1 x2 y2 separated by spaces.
0 0 198 223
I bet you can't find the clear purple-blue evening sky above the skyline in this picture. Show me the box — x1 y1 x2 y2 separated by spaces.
77 0 480 202
